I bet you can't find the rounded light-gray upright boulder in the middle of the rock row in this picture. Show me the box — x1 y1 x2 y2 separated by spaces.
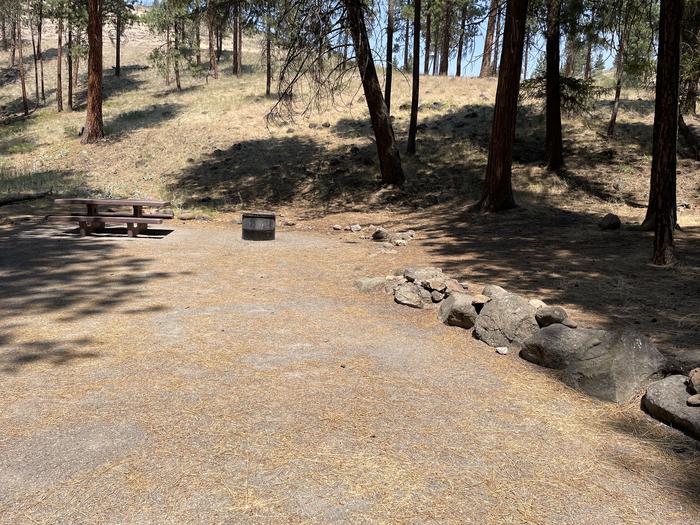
474 287 539 347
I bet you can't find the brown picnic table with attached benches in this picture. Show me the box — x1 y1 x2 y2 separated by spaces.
48 199 173 237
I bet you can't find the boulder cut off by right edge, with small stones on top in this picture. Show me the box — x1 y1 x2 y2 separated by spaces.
642 375 700 439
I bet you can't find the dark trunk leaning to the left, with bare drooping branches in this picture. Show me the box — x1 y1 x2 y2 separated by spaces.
343 0 404 184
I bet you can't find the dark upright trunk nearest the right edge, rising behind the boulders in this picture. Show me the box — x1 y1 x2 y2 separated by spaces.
647 0 684 265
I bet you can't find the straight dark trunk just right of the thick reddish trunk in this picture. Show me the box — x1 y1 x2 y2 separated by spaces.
545 0 564 171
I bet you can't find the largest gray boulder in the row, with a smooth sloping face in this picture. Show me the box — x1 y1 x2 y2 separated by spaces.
563 329 668 403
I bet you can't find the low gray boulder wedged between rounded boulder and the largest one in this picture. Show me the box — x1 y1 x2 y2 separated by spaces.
520 324 606 370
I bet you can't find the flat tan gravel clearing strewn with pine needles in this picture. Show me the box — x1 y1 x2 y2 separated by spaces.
0 221 700 525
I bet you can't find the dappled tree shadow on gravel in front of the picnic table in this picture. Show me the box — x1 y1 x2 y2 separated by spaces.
0 220 171 374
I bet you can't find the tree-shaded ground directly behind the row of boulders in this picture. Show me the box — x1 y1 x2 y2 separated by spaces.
402 201 700 352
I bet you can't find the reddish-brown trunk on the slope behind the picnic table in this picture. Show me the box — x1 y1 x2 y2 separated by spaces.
83 0 104 144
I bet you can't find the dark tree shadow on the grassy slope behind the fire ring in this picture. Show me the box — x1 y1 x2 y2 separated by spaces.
169 136 377 209
